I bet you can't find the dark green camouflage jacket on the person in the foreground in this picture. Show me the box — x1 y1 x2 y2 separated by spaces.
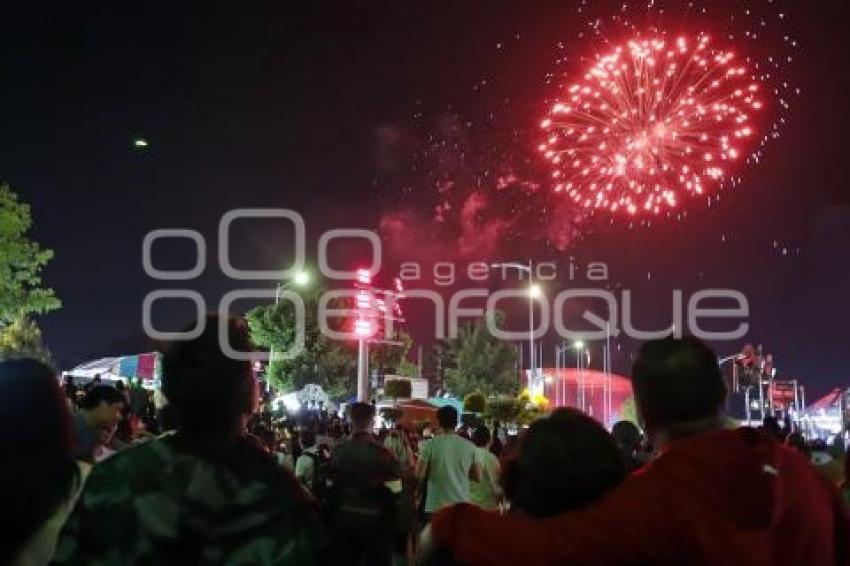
55 433 325 566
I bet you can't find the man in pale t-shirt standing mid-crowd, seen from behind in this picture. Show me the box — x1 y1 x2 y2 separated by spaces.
416 406 481 518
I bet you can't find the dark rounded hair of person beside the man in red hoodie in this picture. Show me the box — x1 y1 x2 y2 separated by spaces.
502 408 626 517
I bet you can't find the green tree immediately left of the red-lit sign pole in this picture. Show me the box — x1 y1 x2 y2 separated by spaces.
246 286 356 397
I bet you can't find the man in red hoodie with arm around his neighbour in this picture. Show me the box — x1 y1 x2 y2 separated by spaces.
423 338 850 566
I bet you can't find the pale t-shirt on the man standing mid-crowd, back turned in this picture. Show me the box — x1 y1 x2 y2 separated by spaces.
419 434 475 513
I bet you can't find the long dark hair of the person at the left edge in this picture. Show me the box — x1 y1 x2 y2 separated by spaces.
0 359 79 564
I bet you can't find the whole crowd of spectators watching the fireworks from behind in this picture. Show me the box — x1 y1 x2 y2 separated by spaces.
0 312 850 566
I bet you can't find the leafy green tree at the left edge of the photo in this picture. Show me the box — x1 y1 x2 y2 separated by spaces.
0 185 61 352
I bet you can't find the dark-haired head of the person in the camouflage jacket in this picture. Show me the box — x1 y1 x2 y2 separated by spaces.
162 315 256 437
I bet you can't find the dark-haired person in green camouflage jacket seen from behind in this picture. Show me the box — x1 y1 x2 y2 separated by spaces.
54 317 326 566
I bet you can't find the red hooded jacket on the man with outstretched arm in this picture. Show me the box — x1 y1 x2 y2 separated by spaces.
432 429 850 566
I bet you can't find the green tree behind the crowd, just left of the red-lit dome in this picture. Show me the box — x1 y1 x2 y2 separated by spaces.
444 313 518 397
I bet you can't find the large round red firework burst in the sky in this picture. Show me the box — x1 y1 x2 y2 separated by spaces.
539 35 762 215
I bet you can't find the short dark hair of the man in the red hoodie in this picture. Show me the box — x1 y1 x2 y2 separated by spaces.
632 337 726 430
